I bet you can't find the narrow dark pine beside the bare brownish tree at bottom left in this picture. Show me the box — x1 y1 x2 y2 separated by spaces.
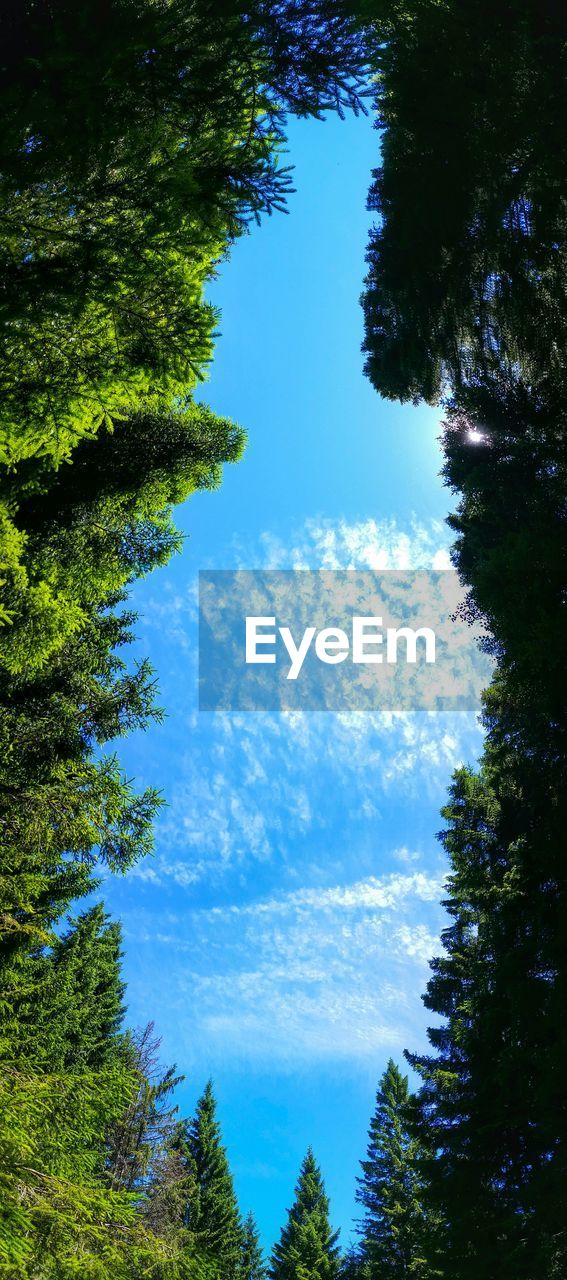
187 1080 243 1280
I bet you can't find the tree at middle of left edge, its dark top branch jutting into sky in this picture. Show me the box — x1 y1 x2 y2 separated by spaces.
0 404 242 956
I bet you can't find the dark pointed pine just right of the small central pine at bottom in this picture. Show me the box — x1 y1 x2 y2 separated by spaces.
356 1059 434 1280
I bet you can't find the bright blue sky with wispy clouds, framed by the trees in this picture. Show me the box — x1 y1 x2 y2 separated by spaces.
99 110 481 1248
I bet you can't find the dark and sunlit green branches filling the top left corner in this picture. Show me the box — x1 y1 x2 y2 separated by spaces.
0 0 366 462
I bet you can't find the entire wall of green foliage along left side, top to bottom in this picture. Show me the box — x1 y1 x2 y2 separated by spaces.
0 0 381 1280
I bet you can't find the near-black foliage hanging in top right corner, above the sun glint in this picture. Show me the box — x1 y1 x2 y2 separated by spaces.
363 0 567 401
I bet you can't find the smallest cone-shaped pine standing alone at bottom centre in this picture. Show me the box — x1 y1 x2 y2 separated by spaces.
269 1148 339 1280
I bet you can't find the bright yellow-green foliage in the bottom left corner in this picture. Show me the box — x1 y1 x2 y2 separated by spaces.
0 1068 159 1280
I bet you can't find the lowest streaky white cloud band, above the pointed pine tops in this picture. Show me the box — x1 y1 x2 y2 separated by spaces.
125 873 442 1069
